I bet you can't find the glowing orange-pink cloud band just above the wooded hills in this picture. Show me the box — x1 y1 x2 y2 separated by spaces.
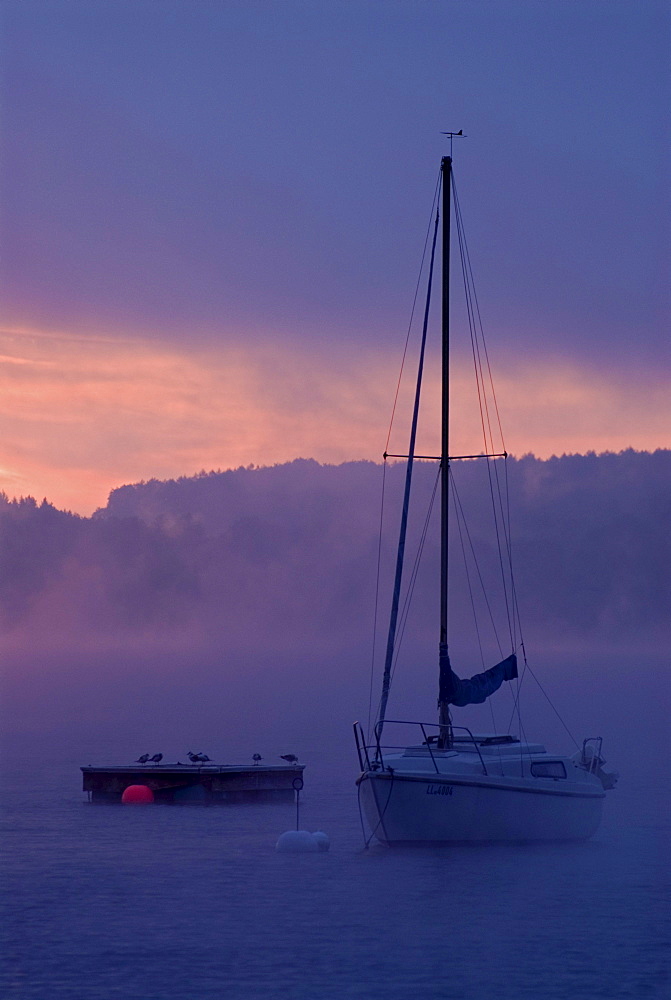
0 329 669 513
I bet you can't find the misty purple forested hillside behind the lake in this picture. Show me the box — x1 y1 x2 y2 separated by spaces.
0 450 671 652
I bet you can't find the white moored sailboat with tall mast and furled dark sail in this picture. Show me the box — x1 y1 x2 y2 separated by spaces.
354 148 617 845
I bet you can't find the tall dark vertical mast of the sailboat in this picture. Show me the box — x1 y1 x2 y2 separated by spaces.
438 150 452 742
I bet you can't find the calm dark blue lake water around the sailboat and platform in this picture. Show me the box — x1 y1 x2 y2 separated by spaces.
2 660 669 1000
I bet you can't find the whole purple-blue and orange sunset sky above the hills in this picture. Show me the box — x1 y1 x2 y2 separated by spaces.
0 0 671 514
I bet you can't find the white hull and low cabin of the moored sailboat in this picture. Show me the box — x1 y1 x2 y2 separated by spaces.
359 754 605 844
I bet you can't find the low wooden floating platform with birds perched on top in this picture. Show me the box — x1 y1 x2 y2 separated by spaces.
81 764 305 805
